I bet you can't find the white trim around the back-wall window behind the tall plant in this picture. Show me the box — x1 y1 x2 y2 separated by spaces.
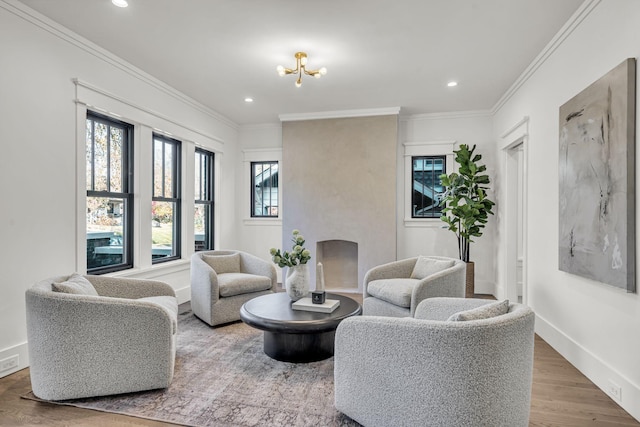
403 140 457 228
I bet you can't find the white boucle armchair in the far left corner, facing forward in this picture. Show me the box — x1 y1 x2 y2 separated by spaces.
191 250 278 326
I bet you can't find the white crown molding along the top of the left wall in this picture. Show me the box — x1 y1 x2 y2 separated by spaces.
0 0 238 130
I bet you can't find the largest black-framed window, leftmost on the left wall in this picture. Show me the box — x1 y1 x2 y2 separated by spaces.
86 112 133 274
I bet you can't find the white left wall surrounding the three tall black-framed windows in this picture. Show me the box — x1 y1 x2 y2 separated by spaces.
0 0 237 376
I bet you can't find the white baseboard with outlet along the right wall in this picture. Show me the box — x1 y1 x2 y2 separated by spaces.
536 314 640 421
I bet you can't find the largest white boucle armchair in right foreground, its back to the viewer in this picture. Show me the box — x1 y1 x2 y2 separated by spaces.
334 298 534 427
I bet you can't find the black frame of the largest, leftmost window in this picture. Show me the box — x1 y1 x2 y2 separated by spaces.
84 110 134 275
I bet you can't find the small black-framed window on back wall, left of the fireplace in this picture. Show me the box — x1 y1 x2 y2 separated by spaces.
251 162 278 218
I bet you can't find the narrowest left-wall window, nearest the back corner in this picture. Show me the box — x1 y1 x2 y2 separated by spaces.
193 148 213 251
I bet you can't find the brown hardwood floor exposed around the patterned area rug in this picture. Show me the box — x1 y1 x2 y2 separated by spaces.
0 300 640 427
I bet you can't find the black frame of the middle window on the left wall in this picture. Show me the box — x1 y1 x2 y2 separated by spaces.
150 132 182 264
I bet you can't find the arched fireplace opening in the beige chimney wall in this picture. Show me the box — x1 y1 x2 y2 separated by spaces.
316 240 358 291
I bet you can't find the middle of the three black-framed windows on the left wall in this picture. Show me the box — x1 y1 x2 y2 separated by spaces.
151 134 180 263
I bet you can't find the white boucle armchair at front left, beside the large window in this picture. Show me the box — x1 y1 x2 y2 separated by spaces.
25 275 178 400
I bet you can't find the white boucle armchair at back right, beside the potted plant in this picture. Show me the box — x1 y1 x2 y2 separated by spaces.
362 256 467 317
